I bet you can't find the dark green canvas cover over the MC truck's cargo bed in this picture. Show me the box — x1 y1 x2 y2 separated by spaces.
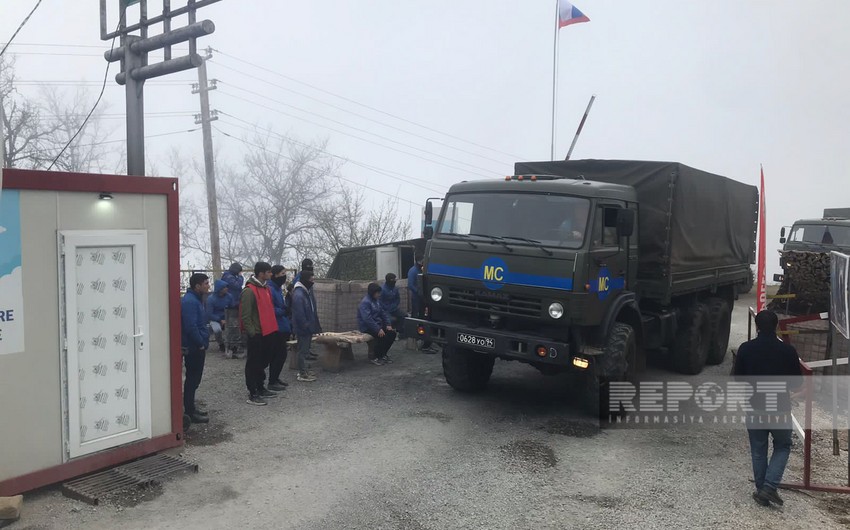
515 160 758 279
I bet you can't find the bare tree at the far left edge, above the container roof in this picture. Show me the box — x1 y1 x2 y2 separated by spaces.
0 57 51 169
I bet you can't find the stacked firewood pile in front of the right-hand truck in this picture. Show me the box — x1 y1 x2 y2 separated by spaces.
769 250 830 315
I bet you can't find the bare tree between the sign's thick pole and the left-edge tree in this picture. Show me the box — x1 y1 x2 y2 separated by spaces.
42 87 113 173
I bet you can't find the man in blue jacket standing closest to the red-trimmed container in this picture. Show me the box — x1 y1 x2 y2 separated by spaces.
180 273 210 423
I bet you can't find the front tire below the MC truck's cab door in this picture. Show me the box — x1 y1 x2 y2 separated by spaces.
585 322 638 420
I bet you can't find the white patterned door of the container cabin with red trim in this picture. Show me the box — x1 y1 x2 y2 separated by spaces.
59 230 151 458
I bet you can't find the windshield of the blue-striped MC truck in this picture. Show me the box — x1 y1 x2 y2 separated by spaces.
437 193 590 248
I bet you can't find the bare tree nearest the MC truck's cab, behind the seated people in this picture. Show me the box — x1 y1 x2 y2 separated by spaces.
298 186 409 271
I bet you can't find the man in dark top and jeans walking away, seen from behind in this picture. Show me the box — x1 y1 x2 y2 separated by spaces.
734 311 802 506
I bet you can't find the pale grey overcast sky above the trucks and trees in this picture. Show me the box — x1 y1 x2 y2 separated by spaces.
0 0 850 272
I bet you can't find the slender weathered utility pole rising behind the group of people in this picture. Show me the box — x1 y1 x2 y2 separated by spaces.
192 48 221 277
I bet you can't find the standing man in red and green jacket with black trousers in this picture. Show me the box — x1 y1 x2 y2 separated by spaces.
239 261 279 405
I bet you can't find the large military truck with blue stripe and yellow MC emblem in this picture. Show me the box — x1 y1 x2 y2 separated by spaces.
406 160 758 412
